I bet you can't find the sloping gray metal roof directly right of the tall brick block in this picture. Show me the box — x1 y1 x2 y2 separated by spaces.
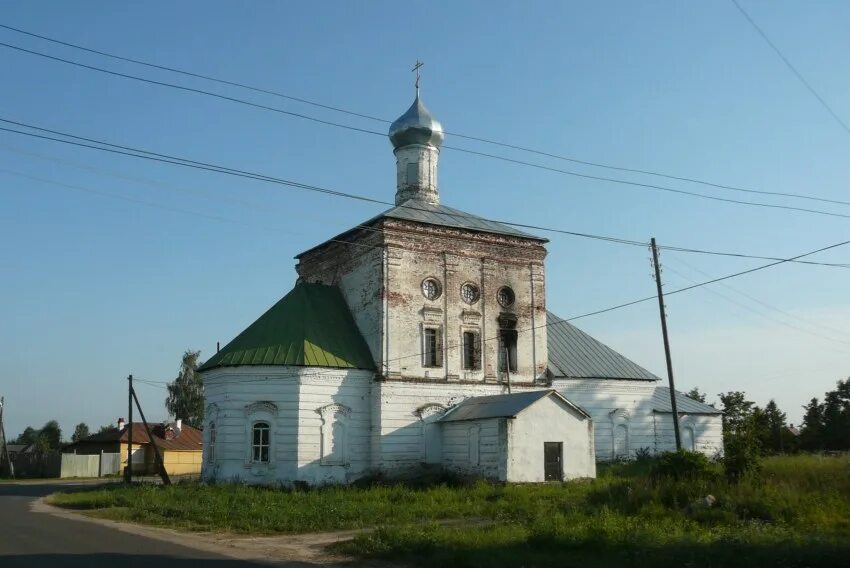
546 310 660 381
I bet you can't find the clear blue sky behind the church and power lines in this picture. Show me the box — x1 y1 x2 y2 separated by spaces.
0 0 850 436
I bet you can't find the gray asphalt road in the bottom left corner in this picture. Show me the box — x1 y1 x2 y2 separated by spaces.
0 484 268 568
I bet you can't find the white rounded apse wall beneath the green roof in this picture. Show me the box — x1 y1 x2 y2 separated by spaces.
203 366 373 484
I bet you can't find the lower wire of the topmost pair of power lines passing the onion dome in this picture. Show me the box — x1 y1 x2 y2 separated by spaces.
0 42 850 218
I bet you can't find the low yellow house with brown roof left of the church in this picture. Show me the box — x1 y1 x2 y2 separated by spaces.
62 418 203 475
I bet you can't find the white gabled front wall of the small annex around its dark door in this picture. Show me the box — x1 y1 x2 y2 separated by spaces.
507 396 596 482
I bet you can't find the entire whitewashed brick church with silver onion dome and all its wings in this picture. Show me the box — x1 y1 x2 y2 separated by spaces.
201 86 722 484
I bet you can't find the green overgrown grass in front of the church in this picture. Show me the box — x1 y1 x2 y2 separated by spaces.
53 456 850 568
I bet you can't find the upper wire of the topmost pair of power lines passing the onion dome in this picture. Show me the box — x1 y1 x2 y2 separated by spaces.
0 24 850 210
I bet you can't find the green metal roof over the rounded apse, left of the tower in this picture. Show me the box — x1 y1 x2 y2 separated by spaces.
200 283 375 371
